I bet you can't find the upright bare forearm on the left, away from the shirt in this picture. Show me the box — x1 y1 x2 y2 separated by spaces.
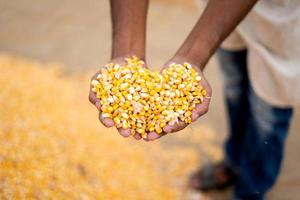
110 0 149 59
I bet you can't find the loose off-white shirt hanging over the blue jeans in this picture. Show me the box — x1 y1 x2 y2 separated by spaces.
197 0 300 107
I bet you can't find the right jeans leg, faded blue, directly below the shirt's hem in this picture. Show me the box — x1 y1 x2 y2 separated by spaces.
235 89 293 200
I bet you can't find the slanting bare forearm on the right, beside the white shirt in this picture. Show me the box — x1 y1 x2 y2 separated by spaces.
175 0 258 69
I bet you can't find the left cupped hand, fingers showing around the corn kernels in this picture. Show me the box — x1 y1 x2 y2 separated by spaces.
89 56 147 140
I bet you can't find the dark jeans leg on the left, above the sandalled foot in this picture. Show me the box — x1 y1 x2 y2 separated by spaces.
217 49 250 168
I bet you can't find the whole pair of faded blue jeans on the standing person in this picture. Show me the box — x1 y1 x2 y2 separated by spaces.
217 49 293 200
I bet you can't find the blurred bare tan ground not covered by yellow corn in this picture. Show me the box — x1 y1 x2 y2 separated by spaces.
0 0 300 200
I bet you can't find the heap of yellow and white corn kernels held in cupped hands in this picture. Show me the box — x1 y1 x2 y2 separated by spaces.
91 57 206 138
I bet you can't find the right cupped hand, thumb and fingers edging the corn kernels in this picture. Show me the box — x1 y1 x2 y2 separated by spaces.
147 57 212 140
